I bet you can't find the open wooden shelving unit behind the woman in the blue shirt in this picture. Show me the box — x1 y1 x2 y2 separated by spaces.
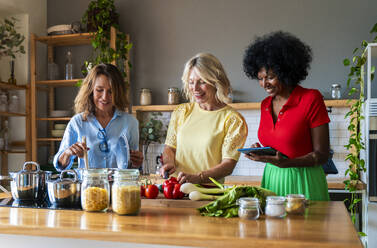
30 27 130 161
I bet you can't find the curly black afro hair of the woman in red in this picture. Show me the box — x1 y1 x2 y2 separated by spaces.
243 31 312 86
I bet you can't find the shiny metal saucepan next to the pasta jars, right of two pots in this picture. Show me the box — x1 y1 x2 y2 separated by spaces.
47 170 81 208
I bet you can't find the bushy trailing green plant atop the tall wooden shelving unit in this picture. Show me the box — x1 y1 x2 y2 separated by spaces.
82 0 132 81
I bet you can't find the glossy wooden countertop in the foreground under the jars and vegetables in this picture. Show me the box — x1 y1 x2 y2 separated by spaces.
0 202 362 248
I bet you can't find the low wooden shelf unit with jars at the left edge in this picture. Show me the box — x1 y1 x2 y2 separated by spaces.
0 82 31 178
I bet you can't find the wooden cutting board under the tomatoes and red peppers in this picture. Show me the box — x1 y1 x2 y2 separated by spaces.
141 194 210 208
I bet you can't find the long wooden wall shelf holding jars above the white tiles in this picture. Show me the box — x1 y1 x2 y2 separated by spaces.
132 99 354 114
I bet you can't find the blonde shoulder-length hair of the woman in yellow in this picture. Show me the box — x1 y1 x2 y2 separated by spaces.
182 53 232 103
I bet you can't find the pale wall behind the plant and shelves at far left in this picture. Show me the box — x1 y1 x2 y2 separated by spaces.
0 0 47 171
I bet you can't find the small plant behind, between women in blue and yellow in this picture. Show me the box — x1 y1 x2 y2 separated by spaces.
140 112 166 174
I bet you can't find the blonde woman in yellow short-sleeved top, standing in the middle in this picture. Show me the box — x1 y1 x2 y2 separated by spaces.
160 53 247 183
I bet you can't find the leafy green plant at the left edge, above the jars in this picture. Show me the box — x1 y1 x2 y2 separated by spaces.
0 17 25 59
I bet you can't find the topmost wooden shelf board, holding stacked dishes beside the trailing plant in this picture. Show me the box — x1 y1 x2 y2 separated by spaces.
36 33 94 46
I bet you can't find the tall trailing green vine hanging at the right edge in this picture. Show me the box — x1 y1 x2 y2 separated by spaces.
343 23 377 236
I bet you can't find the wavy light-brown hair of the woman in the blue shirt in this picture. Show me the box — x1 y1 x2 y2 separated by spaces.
74 64 129 120
